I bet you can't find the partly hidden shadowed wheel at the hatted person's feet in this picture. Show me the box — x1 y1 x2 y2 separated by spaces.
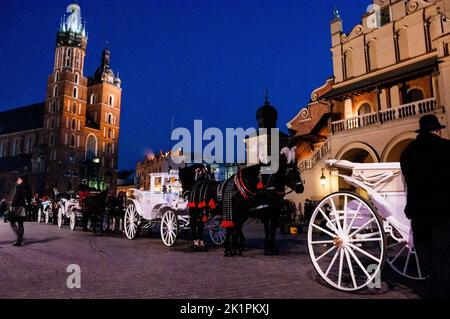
386 241 426 280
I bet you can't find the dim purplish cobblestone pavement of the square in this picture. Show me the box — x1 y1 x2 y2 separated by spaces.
0 221 418 299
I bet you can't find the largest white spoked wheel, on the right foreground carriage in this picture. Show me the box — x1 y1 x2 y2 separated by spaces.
308 192 386 291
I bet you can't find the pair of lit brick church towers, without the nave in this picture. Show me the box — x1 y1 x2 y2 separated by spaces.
41 4 122 192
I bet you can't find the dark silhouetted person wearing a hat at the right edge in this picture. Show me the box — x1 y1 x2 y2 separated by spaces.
400 114 450 298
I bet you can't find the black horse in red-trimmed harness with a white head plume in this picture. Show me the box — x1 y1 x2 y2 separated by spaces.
180 148 304 256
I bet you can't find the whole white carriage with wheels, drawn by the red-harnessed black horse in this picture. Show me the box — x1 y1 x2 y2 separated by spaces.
124 171 225 247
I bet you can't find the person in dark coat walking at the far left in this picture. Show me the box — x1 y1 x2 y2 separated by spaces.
9 176 31 246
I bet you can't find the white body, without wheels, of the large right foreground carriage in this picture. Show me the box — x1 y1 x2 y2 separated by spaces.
326 160 412 245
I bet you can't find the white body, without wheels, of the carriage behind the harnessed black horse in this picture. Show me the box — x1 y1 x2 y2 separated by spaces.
128 171 187 221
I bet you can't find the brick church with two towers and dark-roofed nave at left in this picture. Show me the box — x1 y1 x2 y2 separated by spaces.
0 4 122 198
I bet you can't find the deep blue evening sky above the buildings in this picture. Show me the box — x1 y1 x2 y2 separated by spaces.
0 0 371 169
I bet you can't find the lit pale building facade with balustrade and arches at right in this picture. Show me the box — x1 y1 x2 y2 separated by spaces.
287 0 450 202
